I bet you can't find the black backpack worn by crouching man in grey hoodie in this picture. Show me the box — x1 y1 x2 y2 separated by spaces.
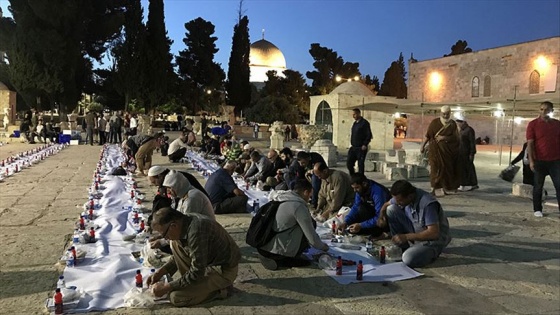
245 201 282 248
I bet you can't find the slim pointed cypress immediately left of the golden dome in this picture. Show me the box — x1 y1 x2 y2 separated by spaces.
226 1 251 113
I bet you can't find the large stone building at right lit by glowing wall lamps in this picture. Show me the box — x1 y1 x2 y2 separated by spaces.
401 37 560 144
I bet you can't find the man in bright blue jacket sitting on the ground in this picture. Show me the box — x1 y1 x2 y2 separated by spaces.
338 173 391 238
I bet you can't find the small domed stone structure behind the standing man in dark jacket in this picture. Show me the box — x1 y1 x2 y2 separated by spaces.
309 81 403 152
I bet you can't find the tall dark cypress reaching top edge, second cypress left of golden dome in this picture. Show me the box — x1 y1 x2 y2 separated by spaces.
141 0 173 111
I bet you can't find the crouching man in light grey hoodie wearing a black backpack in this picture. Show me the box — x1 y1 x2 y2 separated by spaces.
257 180 329 270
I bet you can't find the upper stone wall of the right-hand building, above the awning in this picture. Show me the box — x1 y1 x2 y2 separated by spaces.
408 37 560 102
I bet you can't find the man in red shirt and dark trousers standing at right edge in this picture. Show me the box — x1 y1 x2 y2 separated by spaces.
526 101 560 218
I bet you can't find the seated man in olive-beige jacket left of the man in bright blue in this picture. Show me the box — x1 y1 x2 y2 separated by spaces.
313 162 354 221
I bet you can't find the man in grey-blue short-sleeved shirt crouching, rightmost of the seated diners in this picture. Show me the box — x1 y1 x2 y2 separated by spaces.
378 180 451 268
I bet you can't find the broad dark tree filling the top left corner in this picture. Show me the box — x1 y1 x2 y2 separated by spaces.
0 0 124 115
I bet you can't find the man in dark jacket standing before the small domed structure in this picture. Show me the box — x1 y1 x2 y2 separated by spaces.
346 108 372 175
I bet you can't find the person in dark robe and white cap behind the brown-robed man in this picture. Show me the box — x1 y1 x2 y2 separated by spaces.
457 117 478 191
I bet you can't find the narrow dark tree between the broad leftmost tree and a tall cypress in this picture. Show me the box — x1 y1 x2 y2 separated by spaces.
111 0 147 110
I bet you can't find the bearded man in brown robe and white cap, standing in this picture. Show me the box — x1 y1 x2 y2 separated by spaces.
420 105 460 197
